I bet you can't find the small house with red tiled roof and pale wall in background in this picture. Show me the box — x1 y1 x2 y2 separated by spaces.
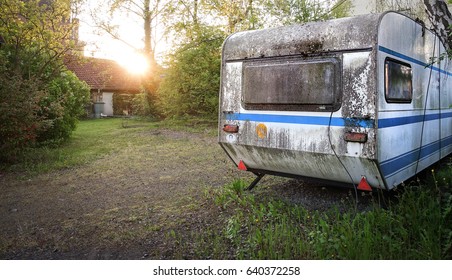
65 57 141 117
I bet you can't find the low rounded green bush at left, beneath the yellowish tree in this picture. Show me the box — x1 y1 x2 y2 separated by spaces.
0 66 89 160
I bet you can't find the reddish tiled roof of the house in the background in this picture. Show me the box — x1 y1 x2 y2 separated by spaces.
65 57 141 93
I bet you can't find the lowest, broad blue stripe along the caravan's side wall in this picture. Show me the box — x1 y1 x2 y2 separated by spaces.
380 136 452 177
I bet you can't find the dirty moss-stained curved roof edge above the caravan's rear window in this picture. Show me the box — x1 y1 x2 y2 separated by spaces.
223 13 386 61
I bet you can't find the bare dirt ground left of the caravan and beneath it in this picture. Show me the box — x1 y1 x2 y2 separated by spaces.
0 129 364 259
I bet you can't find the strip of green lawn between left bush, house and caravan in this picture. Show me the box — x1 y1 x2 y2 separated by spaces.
0 118 216 176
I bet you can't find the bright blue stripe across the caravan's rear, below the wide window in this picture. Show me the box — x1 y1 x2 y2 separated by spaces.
226 113 375 128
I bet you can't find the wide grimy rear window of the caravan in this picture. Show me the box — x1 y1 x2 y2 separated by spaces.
242 58 341 111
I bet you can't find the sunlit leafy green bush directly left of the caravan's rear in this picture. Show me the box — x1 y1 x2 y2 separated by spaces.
158 28 224 118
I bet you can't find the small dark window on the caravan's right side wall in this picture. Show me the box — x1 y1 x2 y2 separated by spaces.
385 58 413 103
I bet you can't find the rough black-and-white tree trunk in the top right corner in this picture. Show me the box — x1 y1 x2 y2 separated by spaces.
424 0 452 50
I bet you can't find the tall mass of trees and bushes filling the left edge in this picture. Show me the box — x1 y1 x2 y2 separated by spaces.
0 0 89 160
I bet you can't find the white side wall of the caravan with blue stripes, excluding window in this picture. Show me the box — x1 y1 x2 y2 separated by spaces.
377 13 451 188
